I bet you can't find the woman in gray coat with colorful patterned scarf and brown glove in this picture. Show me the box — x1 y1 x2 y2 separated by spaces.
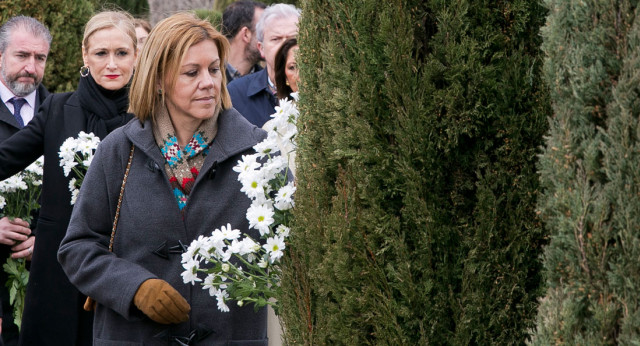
58 13 267 346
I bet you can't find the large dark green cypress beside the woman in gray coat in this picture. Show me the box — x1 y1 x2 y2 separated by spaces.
281 0 550 345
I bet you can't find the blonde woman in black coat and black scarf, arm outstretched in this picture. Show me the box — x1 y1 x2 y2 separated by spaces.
0 11 136 346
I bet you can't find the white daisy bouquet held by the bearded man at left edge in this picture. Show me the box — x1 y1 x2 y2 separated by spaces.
0 157 44 327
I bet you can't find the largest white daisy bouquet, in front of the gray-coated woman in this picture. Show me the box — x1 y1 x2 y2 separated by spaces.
182 94 299 314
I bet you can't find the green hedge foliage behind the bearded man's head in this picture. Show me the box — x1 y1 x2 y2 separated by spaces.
0 0 93 92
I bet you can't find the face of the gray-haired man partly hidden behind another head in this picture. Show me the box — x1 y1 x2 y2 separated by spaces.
258 16 298 81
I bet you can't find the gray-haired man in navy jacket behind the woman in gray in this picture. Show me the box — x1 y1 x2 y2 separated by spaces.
228 4 300 127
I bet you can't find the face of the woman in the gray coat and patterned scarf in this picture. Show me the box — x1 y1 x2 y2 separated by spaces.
163 40 222 129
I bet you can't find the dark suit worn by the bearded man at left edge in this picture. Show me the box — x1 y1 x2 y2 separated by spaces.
0 84 49 345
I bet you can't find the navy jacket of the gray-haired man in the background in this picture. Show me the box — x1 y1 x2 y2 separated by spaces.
227 68 278 127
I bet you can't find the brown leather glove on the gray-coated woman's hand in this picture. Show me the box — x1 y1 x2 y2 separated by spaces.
133 279 191 324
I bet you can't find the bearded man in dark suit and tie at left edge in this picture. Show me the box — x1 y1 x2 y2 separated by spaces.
0 16 51 346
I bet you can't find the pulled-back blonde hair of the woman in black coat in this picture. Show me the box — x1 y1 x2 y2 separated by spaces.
82 11 138 52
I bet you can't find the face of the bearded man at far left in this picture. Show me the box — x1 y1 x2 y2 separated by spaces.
0 28 49 96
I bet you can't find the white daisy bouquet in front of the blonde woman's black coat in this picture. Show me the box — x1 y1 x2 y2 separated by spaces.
58 131 100 205
